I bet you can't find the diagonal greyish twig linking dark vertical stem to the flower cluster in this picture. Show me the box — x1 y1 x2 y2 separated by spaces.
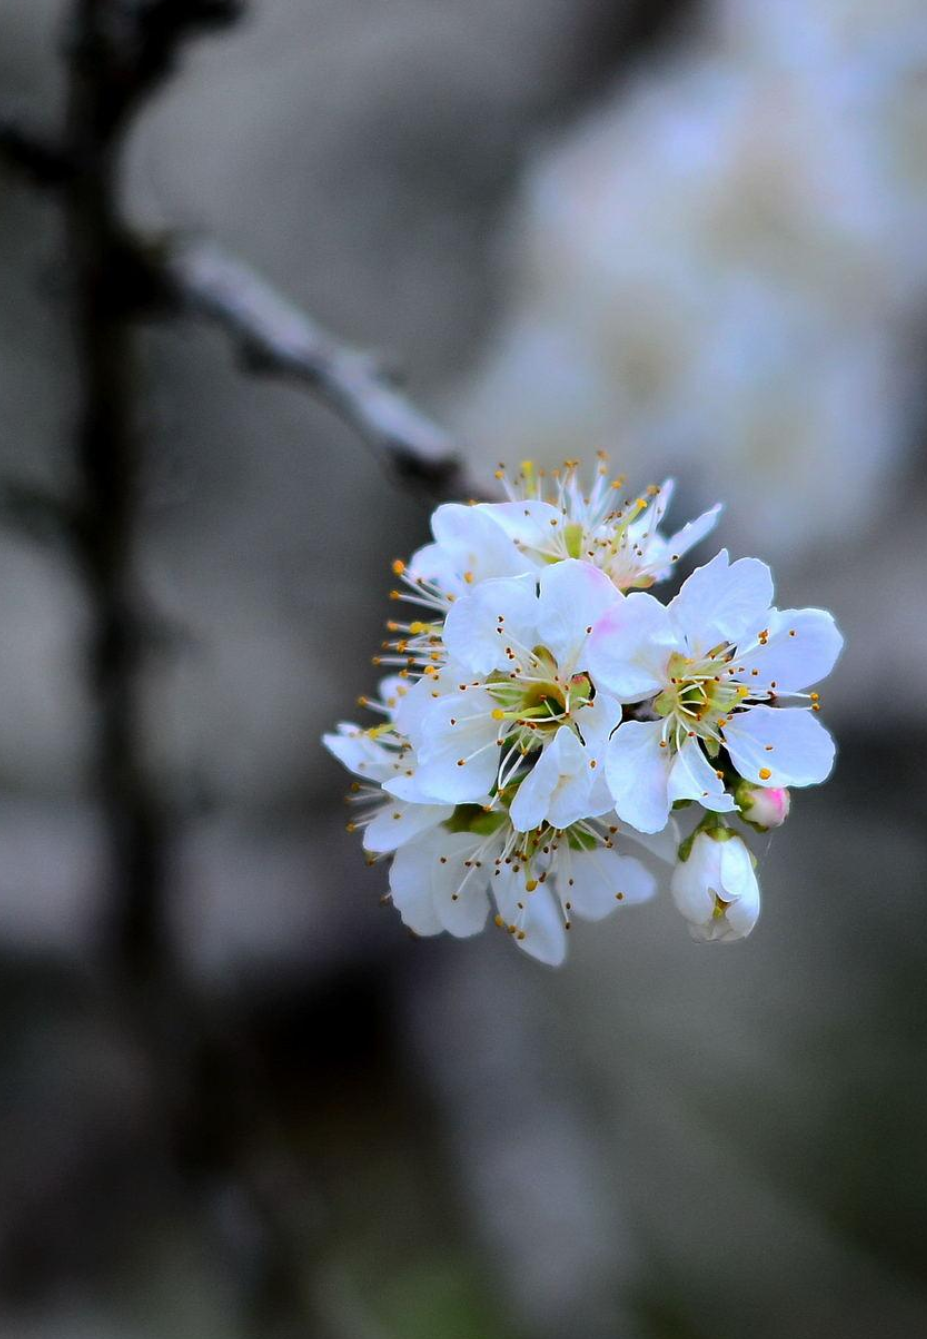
154 241 485 498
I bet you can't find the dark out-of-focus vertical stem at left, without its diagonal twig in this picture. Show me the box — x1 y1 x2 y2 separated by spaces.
0 0 342 1339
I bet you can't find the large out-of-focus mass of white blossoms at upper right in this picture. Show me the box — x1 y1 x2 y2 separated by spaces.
457 0 927 558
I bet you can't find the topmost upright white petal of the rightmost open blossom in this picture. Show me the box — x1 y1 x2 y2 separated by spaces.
668 549 773 655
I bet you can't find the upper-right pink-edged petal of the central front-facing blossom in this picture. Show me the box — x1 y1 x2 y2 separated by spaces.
537 558 622 674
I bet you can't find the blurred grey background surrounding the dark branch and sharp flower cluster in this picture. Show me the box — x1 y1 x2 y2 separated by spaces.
0 0 927 1339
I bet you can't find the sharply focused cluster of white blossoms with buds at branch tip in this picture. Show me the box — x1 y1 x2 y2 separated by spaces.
324 461 843 964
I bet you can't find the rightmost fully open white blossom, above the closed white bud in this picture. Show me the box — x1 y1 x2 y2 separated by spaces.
589 549 843 832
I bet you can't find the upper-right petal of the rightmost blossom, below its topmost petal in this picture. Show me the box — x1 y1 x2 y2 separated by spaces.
738 609 844 692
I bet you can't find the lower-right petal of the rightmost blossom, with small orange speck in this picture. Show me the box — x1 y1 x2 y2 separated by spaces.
723 707 836 786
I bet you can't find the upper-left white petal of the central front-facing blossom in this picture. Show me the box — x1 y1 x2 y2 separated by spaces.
443 577 537 674
